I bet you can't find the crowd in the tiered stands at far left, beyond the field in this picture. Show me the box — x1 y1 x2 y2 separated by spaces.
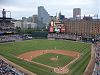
0 21 20 42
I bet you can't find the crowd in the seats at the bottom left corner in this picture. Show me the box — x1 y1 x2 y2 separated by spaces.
0 59 26 75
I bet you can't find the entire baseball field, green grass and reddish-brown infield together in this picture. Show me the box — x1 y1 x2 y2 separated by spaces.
0 40 91 75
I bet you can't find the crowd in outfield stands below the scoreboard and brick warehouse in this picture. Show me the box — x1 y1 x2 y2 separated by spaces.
48 33 100 41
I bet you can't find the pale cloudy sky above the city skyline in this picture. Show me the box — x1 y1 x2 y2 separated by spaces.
0 0 100 19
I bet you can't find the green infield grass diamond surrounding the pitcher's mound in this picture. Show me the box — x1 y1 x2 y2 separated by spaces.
32 53 74 67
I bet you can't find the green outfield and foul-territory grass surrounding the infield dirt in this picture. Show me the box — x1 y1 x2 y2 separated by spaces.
0 40 91 75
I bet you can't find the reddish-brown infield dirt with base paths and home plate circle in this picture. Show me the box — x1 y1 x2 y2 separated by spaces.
18 50 81 74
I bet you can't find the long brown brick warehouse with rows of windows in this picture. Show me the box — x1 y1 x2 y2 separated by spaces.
64 17 100 37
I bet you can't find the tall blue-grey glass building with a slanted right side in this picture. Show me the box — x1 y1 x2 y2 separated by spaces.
38 6 50 29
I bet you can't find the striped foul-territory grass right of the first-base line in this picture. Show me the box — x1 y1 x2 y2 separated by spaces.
68 49 91 75
